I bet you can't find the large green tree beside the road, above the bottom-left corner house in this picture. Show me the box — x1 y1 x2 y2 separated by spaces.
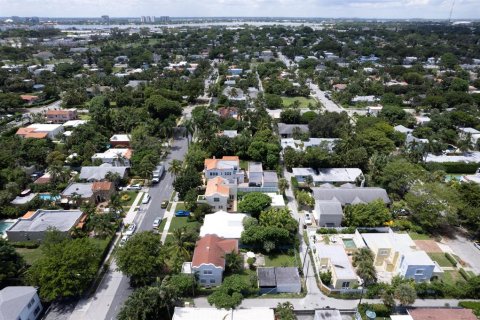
27 238 101 301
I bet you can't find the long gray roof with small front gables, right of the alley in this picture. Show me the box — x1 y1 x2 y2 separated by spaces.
312 186 390 206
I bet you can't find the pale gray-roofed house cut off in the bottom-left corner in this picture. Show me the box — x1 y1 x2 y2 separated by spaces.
0 286 43 320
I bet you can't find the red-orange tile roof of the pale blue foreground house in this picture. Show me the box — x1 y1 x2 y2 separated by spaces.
192 234 238 268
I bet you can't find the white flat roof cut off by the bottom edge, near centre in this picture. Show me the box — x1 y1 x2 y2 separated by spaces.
172 307 275 320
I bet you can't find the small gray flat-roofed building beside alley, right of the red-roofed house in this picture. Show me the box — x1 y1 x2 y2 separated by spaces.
257 267 302 294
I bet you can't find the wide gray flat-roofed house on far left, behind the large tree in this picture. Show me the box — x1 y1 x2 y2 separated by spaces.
6 209 84 241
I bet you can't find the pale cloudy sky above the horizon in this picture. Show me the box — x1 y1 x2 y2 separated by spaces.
0 0 480 19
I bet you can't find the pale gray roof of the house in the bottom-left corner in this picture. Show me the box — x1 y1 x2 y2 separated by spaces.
0 286 37 320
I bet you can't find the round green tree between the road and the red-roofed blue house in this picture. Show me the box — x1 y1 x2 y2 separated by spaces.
115 231 165 286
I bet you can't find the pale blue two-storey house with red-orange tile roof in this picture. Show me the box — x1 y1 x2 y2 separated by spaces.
187 234 238 287
